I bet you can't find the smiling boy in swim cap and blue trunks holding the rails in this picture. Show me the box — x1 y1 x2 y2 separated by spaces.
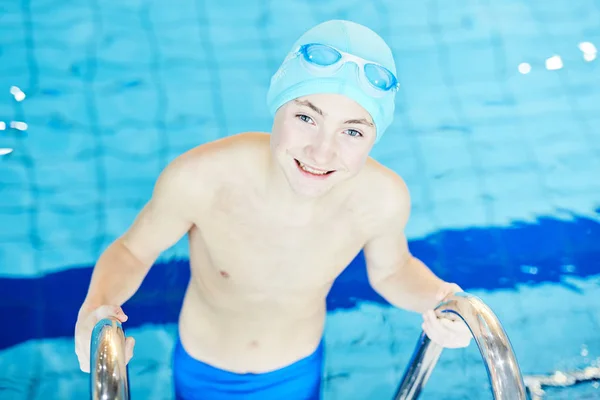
75 20 471 400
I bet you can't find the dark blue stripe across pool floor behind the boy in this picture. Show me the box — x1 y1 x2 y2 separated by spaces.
0 216 600 349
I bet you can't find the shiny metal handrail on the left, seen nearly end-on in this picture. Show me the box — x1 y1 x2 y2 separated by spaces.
90 318 129 400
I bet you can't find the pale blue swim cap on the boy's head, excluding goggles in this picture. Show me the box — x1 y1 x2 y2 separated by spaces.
267 20 397 142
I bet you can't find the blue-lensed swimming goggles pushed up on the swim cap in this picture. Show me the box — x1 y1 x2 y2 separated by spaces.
295 43 400 95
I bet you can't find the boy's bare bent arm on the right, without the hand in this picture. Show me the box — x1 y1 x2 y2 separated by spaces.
364 178 458 313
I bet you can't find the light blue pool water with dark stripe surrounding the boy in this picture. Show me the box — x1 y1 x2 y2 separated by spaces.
0 0 600 400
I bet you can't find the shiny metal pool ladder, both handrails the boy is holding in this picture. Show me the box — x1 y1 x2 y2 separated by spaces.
90 293 527 400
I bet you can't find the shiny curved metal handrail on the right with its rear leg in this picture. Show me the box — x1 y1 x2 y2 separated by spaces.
394 293 527 400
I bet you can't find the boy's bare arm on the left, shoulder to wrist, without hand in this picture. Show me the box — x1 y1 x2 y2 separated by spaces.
81 154 203 311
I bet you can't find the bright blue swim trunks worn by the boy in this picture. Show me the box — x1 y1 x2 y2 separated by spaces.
173 338 323 400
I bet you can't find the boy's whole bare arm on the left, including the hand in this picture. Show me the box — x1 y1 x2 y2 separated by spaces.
75 151 207 372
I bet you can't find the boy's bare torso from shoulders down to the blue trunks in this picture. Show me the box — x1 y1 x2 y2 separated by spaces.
179 133 390 373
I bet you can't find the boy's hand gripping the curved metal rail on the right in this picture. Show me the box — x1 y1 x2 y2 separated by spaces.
422 283 473 349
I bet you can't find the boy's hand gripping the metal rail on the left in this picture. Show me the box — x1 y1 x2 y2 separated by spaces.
75 305 135 373
